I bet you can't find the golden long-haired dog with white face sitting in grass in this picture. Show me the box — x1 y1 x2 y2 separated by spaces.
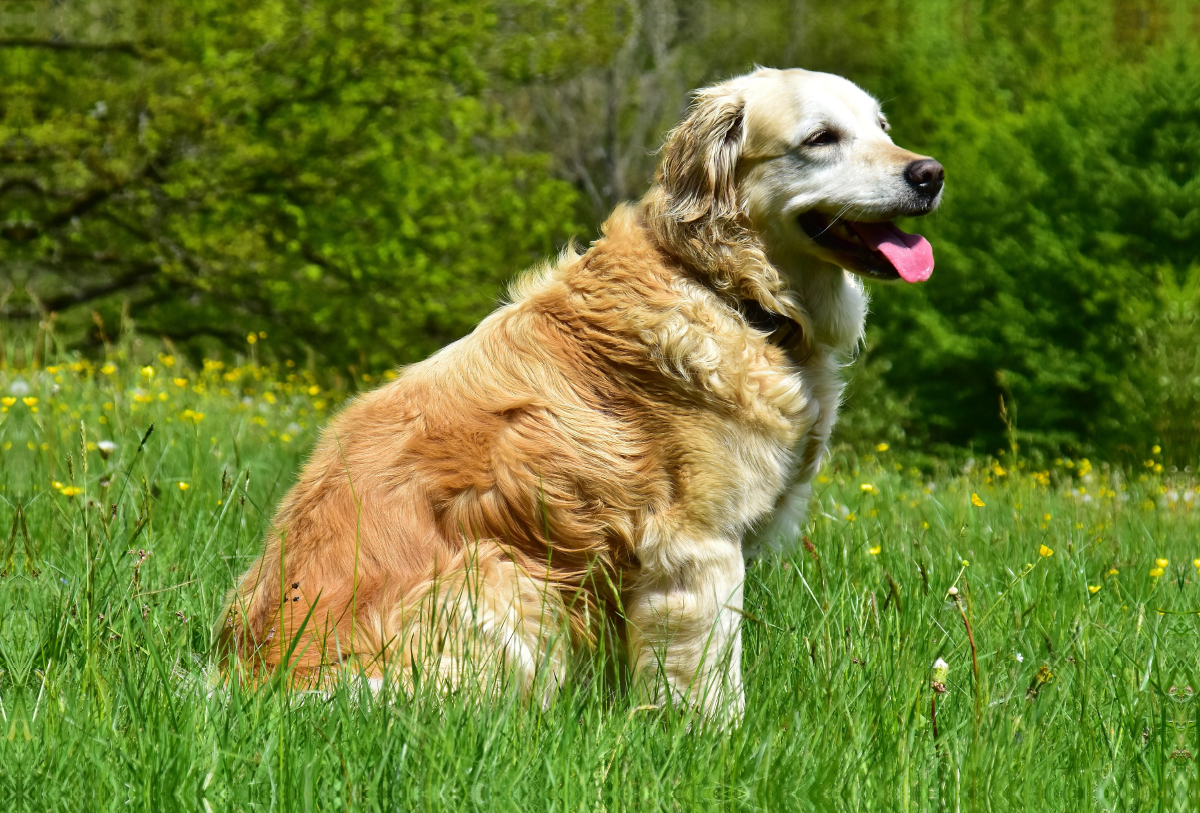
217 68 944 722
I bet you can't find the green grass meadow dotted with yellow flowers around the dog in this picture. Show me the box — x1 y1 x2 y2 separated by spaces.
0 357 1200 811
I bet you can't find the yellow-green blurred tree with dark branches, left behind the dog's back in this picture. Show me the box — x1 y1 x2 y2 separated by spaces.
0 0 575 368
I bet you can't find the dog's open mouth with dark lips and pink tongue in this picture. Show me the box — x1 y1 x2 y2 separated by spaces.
799 211 934 282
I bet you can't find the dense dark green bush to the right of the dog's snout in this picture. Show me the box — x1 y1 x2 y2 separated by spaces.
876 39 1200 462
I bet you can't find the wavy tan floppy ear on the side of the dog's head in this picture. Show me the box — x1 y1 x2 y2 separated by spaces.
658 86 745 223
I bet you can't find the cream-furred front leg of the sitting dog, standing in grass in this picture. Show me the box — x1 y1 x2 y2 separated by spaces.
625 538 745 724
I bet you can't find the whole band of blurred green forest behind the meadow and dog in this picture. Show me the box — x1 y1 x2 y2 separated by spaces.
0 0 1200 468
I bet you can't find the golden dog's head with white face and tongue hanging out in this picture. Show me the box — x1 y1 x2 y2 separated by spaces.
658 70 944 282
